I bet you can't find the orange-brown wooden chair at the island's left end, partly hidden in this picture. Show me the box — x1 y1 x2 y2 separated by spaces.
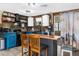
21 34 29 56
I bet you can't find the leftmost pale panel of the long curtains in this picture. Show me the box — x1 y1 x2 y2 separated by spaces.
60 13 68 36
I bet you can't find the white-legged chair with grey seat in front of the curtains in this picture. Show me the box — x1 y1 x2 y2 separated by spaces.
61 34 77 56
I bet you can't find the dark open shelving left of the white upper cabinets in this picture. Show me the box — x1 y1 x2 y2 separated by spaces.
15 14 28 31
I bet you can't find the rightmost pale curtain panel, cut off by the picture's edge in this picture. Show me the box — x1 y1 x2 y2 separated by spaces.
74 12 79 48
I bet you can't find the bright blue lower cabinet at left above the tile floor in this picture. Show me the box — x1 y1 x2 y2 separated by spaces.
4 32 16 49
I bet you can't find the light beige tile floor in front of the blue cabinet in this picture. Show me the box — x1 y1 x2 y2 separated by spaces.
0 47 21 56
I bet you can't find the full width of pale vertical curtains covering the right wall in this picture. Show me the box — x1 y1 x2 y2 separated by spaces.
60 11 79 48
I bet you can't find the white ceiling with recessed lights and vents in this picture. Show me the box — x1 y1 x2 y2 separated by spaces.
0 3 79 16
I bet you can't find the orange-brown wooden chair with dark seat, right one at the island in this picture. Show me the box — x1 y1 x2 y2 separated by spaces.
29 35 48 56
